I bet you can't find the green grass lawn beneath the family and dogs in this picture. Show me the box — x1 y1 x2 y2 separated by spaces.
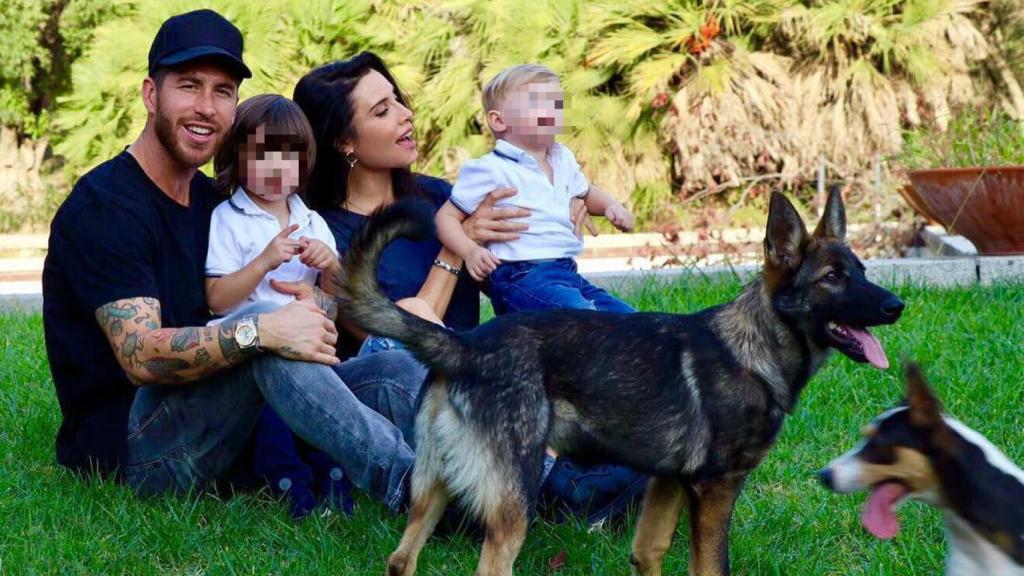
0 281 1024 576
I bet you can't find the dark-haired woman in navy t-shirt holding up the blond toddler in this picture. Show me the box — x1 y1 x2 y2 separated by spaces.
293 52 645 522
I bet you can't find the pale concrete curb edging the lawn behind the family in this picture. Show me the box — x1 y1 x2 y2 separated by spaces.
0 256 1024 314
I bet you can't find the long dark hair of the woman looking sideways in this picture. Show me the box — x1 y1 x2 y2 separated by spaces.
292 52 420 210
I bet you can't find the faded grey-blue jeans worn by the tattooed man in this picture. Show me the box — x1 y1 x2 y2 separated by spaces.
124 301 426 511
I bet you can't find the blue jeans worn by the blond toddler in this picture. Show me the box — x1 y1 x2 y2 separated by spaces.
489 258 636 315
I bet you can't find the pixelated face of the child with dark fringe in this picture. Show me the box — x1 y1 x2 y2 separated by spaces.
239 126 302 203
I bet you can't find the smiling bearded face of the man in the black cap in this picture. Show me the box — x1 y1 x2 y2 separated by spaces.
142 63 239 168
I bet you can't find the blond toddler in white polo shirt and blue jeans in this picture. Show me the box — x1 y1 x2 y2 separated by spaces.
436 65 634 314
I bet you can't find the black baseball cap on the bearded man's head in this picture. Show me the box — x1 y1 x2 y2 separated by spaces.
150 9 253 78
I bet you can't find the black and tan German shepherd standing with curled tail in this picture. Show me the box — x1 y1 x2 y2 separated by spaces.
339 191 903 576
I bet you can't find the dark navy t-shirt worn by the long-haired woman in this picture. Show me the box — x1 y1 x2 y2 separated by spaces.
318 174 480 358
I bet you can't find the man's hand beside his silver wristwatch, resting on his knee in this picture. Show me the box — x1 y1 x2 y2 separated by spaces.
259 299 340 366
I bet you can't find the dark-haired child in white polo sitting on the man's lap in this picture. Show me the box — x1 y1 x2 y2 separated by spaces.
206 94 352 519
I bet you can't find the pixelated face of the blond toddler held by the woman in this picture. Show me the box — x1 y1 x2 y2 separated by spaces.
492 82 565 145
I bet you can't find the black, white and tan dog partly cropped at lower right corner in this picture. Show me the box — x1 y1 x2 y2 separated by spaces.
818 364 1024 576
